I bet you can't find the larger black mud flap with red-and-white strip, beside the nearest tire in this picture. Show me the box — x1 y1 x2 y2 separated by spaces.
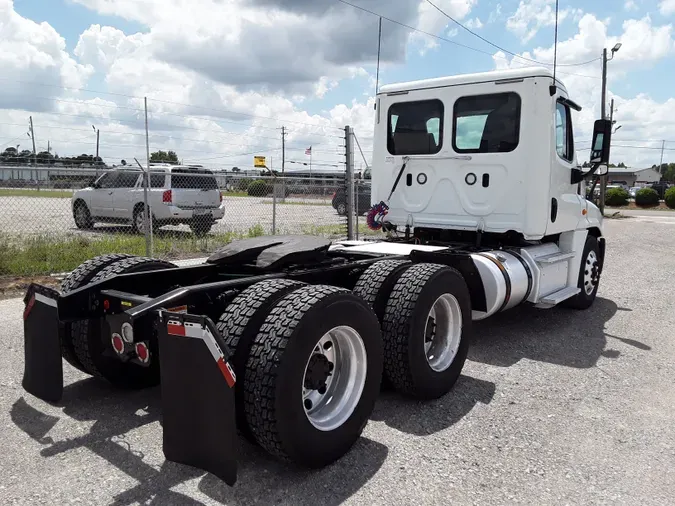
158 311 237 485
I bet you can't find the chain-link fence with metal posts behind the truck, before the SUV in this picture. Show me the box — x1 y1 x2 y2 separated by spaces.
0 165 375 277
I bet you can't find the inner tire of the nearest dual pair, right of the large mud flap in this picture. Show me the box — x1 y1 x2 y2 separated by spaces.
217 279 305 442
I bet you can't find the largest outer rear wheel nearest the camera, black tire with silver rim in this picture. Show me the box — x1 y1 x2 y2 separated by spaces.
244 285 382 467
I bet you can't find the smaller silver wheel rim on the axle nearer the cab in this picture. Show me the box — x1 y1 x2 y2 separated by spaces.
424 293 462 372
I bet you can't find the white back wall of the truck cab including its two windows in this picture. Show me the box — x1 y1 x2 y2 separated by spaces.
385 83 530 231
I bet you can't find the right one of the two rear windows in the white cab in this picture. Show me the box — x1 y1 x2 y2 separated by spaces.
452 92 521 153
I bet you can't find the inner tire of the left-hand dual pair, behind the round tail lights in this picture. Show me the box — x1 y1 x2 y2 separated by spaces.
72 257 176 389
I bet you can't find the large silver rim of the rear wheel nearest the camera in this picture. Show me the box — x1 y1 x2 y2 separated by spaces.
302 325 368 431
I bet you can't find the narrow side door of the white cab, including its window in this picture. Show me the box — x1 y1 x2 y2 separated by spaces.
546 100 585 235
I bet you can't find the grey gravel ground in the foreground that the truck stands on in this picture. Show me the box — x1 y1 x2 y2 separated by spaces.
0 216 675 506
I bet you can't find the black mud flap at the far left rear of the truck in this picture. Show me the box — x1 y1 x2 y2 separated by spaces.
21 284 63 402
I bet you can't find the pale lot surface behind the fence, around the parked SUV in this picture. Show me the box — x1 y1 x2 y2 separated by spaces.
0 197 346 236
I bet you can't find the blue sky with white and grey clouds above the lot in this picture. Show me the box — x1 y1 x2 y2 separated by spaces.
0 0 675 168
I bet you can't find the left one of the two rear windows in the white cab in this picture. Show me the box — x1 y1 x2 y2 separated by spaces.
387 100 444 155
